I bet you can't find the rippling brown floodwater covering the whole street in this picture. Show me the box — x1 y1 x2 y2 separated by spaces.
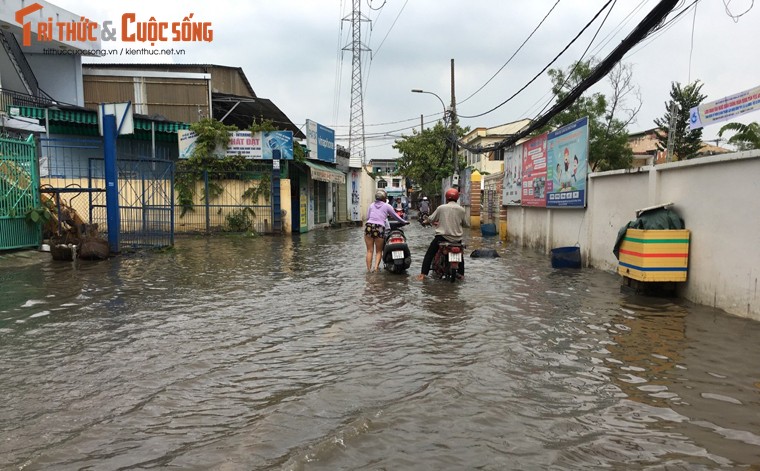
0 223 760 470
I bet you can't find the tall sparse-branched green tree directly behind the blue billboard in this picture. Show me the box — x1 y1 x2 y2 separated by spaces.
545 60 641 172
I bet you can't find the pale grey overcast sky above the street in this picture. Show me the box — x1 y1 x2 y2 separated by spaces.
51 0 760 160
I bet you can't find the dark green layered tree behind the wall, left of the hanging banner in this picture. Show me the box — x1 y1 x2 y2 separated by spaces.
654 80 707 160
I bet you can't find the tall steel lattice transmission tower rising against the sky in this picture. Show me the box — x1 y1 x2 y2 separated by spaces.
343 0 370 168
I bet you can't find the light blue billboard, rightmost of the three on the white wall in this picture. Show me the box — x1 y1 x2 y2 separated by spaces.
546 117 588 208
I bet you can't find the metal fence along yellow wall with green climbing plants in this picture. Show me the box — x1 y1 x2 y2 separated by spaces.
174 166 272 234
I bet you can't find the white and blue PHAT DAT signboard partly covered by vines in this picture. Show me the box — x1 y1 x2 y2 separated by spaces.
177 130 293 160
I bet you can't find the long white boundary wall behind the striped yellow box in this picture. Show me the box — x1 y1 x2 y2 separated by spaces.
507 150 760 320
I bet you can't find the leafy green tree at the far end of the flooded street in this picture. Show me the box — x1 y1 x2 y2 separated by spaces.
393 121 467 200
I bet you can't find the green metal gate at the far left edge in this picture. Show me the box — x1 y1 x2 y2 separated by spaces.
0 136 42 250
